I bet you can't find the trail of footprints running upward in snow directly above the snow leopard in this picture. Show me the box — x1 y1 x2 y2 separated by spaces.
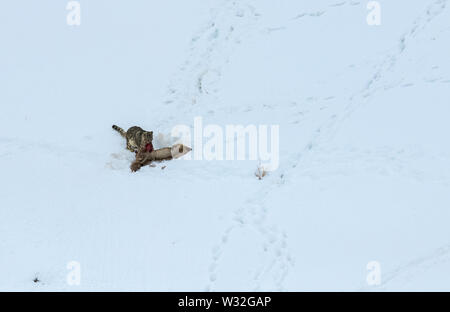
156 0 259 130
